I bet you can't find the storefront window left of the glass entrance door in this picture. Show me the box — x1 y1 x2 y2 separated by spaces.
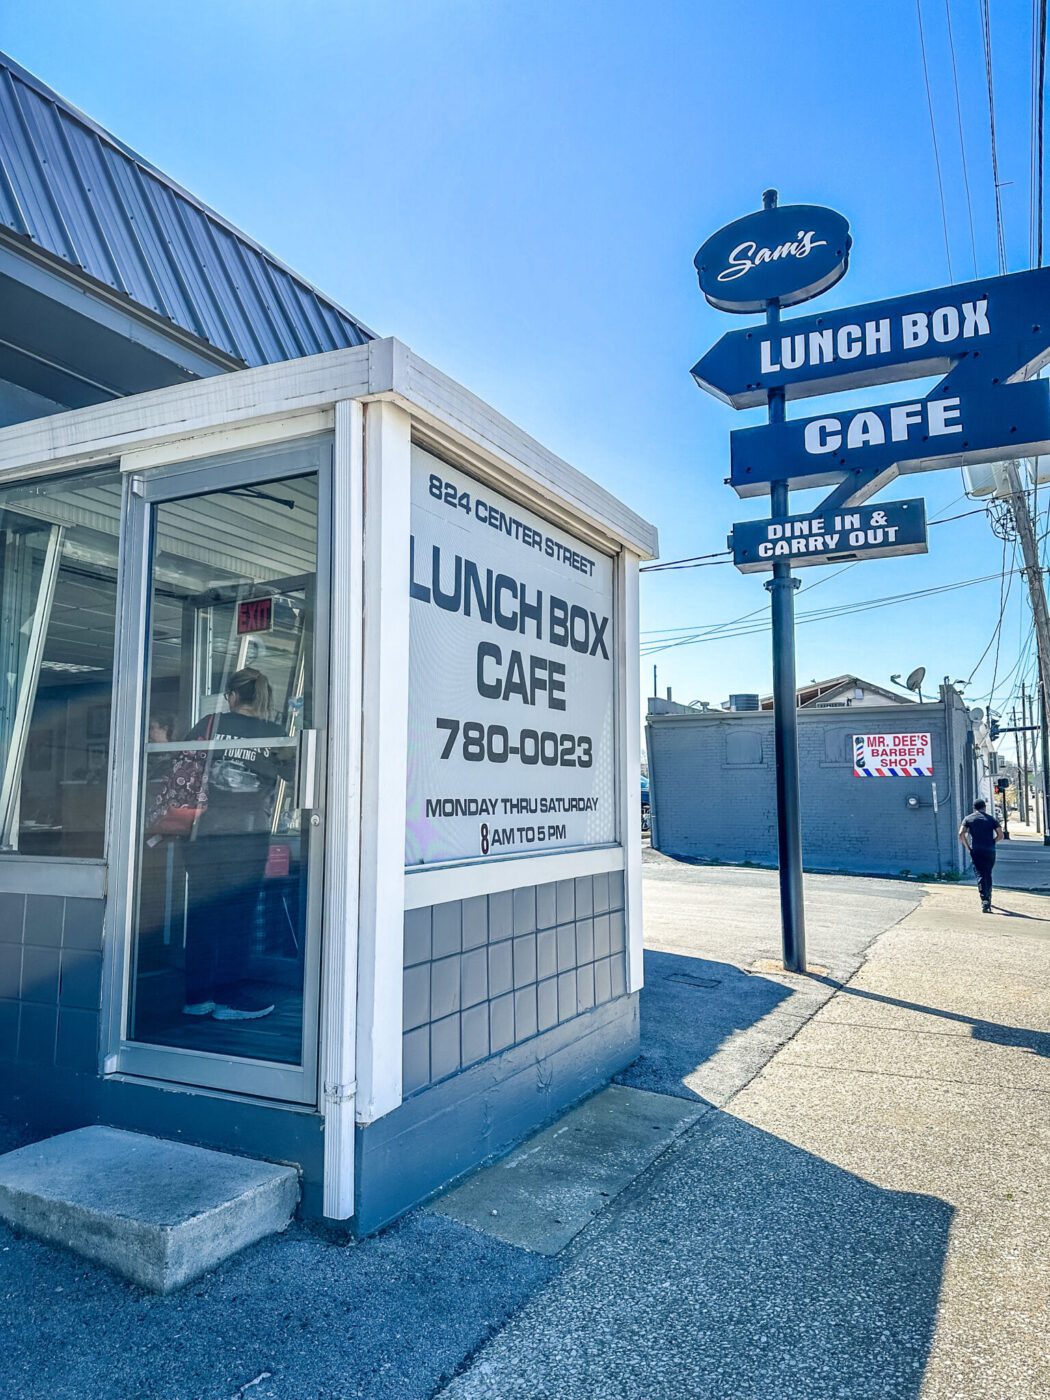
0 468 120 858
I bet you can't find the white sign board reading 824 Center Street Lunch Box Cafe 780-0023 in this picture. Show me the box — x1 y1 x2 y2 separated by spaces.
405 447 616 867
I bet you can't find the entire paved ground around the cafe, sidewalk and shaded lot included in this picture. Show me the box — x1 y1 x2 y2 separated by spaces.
0 854 1050 1400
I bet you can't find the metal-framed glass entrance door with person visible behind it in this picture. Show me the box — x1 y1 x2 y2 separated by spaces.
120 449 328 1102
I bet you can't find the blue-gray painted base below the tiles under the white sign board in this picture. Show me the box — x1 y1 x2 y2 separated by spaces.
353 994 638 1235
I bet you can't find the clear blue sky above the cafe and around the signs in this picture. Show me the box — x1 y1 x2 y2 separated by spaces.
3 0 1050 704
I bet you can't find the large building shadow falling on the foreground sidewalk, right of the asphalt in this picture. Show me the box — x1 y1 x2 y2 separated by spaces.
448 1109 955 1400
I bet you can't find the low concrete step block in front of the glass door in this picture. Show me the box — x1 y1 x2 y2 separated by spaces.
0 1127 300 1294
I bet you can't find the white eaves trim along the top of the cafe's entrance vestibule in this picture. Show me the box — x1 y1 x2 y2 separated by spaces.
0 337 658 559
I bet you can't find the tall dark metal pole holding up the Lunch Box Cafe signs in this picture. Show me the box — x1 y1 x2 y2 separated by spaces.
762 189 806 972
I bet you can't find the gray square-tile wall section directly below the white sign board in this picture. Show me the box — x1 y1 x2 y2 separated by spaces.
402 872 627 1098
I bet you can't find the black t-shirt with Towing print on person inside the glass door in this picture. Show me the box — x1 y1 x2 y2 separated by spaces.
188 710 295 834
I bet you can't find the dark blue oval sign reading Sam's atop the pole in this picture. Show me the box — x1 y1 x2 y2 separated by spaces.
693 204 851 312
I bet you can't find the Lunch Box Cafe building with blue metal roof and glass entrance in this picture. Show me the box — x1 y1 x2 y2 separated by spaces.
0 51 657 1232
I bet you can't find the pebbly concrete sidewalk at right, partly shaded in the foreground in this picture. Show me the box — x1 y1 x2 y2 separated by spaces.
445 888 1050 1400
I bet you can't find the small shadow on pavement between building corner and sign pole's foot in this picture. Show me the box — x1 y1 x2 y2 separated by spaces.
616 949 794 1102
